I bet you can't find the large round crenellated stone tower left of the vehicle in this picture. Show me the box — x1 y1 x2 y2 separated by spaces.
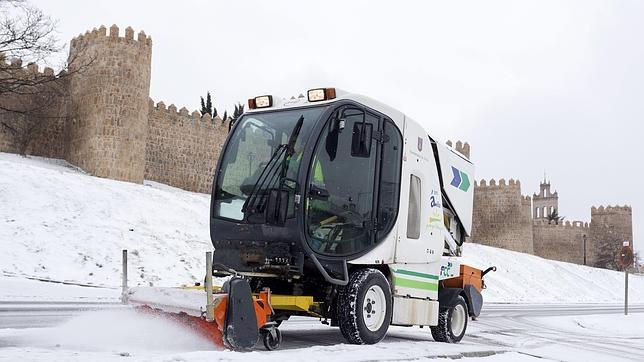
67 25 152 183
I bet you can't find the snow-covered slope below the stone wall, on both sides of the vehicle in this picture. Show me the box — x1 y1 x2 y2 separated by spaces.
0 153 644 303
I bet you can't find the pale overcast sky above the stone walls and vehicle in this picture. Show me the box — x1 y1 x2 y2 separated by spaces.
32 0 644 255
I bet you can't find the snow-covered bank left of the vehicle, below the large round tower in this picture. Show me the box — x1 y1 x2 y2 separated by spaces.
0 153 212 286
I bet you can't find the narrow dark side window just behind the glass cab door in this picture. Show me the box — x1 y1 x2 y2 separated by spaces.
377 120 402 240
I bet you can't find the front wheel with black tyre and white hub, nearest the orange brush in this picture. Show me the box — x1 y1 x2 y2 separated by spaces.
336 269 393 344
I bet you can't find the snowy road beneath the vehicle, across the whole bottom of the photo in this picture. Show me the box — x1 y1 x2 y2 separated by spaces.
0 301 644 362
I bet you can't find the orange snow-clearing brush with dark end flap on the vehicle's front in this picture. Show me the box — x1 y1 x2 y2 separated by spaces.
128 278 281 350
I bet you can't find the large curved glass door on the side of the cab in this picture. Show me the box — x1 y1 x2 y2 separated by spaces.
305 106 380 256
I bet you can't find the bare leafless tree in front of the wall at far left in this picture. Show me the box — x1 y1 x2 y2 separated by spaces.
0 0 88 155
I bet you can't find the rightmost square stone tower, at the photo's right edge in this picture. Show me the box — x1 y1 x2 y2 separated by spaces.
588 205 633 265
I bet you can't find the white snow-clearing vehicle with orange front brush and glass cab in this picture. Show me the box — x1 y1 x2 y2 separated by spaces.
129 88 493 349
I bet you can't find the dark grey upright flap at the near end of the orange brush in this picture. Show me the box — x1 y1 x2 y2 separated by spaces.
224 277 259 350
